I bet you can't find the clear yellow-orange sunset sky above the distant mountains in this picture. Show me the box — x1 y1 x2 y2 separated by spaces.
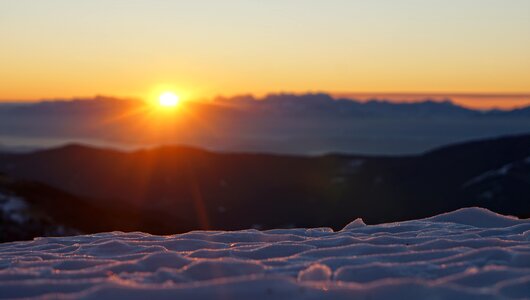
0 0 530 100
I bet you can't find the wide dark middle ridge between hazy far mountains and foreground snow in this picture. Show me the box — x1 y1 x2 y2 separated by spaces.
0 135 530 241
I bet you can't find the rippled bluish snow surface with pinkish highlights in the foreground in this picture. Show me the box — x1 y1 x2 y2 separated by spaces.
0 208 530 300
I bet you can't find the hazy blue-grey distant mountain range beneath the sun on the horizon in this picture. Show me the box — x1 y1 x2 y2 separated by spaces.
0 94 530 155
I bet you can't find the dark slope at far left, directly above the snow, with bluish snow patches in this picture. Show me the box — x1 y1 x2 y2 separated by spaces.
0 174 194 243
